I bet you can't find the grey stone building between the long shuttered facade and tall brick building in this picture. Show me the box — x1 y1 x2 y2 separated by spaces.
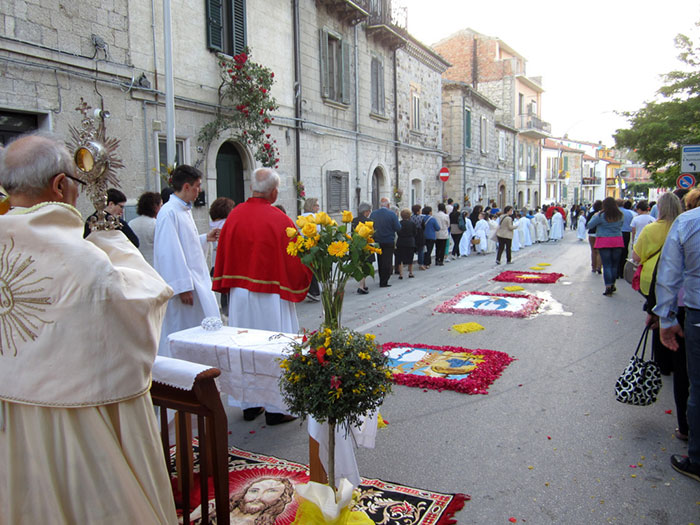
442 80 517 208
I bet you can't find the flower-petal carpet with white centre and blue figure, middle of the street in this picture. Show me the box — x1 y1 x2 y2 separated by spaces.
435 292 542 317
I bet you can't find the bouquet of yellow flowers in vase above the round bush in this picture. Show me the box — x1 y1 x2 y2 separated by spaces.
287 211 381 329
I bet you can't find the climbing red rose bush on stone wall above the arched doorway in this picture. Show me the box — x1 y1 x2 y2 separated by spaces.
198 48 279 168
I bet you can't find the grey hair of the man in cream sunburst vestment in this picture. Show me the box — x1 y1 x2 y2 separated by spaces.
0 132 75 195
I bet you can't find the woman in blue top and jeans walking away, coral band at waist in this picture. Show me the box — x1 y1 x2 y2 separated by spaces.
586 197 625 297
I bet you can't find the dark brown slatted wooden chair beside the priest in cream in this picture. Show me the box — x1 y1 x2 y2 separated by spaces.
151 368 230 525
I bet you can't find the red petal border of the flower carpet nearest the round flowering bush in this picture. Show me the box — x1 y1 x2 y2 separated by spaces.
382 343 515 394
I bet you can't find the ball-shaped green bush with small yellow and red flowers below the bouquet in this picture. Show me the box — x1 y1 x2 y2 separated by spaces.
280 328 391 426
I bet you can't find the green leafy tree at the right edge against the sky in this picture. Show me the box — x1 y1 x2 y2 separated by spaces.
614 22 700 187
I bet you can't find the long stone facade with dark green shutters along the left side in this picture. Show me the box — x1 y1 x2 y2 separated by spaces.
0 0 449 230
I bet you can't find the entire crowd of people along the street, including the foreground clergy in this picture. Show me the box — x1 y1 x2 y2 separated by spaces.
0 129 700 523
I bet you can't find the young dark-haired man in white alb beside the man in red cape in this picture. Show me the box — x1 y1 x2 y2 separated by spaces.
153 164 220 357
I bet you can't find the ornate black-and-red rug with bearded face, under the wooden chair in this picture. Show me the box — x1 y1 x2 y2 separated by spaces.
171 439 470 525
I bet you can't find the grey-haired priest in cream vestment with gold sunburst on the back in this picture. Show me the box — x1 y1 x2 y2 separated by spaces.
0 135 177 525
